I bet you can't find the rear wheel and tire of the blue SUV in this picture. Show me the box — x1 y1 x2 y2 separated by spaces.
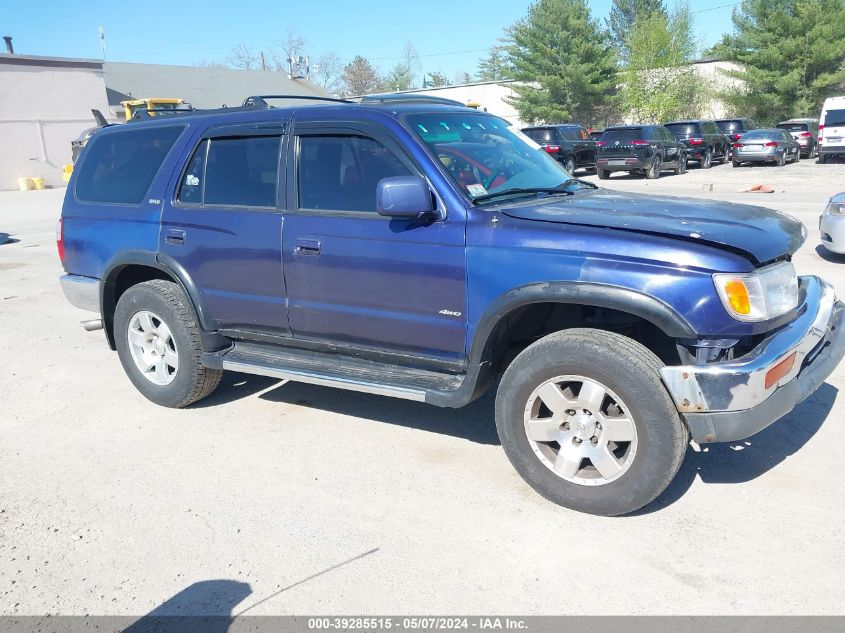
114 279 223 408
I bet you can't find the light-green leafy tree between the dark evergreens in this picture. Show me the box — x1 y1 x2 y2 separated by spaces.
620 4 711 123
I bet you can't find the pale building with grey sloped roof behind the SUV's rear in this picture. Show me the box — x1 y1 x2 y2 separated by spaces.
0 53 329 191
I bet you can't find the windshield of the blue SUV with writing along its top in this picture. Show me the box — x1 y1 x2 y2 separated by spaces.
407 112 570 199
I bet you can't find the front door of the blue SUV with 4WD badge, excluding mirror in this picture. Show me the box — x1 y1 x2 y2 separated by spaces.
283 115 466 363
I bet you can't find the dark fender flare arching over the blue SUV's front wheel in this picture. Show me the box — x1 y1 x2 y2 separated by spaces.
469 281 698 365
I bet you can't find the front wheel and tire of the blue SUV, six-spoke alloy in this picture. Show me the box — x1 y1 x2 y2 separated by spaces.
496 328 689 516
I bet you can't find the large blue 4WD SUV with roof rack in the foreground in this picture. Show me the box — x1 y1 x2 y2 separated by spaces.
57 96 845 515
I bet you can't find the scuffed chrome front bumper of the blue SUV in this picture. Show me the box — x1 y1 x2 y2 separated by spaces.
660 277 845 443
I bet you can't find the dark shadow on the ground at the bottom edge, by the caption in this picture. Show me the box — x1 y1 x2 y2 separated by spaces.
122 580 252 633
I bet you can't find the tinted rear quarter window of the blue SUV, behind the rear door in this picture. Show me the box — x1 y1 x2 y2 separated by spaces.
75 125 185 204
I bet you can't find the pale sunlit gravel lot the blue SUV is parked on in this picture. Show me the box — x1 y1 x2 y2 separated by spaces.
0 161 845 615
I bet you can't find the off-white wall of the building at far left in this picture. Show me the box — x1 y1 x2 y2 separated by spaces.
0 55 108 190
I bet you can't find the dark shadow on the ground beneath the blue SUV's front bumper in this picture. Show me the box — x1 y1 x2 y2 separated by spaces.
629 383 838 516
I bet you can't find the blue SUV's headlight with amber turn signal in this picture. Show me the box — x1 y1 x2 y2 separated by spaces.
713 262 798 321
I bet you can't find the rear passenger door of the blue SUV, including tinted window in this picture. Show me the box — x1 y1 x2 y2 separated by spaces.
159 122 290 338
